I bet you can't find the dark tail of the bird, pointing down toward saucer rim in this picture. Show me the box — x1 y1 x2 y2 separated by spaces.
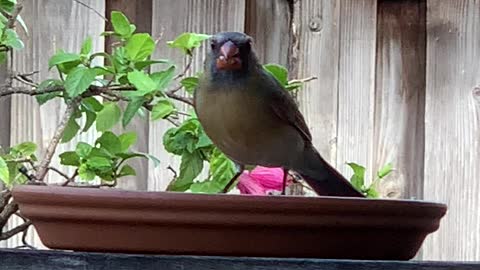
294 147 365 197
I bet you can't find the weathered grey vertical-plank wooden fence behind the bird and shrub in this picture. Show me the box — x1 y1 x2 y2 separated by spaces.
0 0 480 260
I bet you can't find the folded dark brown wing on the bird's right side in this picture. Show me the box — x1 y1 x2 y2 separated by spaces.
268 74 312 142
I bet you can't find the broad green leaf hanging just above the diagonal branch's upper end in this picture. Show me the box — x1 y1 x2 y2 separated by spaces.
65 66 97 97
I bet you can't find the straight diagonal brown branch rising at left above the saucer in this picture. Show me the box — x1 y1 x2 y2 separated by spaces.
35 97 80 181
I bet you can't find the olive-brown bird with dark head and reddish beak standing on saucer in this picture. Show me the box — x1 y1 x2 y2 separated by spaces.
194 32 365 197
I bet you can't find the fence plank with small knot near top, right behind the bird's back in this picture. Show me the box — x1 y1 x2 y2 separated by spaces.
289 0 340 166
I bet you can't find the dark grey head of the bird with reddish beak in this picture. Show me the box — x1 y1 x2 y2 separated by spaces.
206 32 257 78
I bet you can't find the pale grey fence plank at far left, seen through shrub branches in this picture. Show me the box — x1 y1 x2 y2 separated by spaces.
8 0 105 247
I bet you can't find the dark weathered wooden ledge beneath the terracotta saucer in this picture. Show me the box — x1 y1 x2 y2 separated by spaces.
0 249 480 270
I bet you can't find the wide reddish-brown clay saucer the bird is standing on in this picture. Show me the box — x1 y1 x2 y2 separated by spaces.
13 186 447 260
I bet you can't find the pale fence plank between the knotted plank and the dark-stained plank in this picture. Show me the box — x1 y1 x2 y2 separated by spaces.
337 0 377 179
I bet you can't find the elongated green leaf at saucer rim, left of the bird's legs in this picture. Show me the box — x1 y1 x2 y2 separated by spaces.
169 152 203 191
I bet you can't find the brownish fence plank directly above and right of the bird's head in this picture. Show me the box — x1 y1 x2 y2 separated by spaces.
245 0 291 68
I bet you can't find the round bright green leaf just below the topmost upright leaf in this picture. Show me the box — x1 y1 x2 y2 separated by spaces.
125 33 155 61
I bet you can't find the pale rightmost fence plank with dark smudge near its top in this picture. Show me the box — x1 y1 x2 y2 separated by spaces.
424 0 480 260
